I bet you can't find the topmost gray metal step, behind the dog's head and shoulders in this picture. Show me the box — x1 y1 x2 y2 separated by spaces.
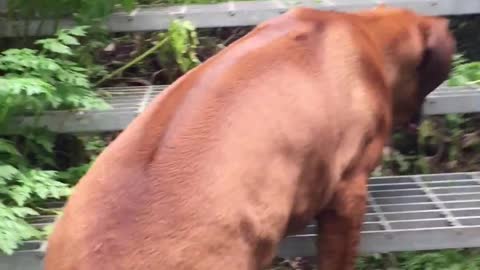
0 0 480 36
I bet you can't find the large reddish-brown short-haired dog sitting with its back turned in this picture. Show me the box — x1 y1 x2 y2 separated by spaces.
45 8 455 270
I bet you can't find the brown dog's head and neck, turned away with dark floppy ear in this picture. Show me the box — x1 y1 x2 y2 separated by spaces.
364 6 456 131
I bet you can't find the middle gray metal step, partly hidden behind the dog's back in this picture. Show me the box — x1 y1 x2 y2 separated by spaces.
5 85 480 134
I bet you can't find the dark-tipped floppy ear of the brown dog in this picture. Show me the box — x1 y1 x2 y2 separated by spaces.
418 17 456 95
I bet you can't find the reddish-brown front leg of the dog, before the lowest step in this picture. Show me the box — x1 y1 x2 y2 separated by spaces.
317 176 368 270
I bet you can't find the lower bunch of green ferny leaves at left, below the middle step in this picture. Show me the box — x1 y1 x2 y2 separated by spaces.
0 130 104 254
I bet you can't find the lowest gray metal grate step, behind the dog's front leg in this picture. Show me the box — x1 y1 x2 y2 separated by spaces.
0 172 480 270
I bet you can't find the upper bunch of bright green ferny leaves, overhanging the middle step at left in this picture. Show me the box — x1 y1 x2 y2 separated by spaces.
0 27 107 124
